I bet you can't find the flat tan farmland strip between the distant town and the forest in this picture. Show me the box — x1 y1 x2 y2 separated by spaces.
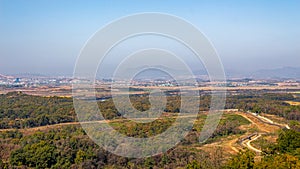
0 85 300 97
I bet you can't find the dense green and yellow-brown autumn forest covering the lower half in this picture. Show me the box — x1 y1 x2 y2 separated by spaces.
0 92 300 169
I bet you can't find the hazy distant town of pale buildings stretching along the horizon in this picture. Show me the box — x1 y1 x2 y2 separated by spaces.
0 72 300 97
